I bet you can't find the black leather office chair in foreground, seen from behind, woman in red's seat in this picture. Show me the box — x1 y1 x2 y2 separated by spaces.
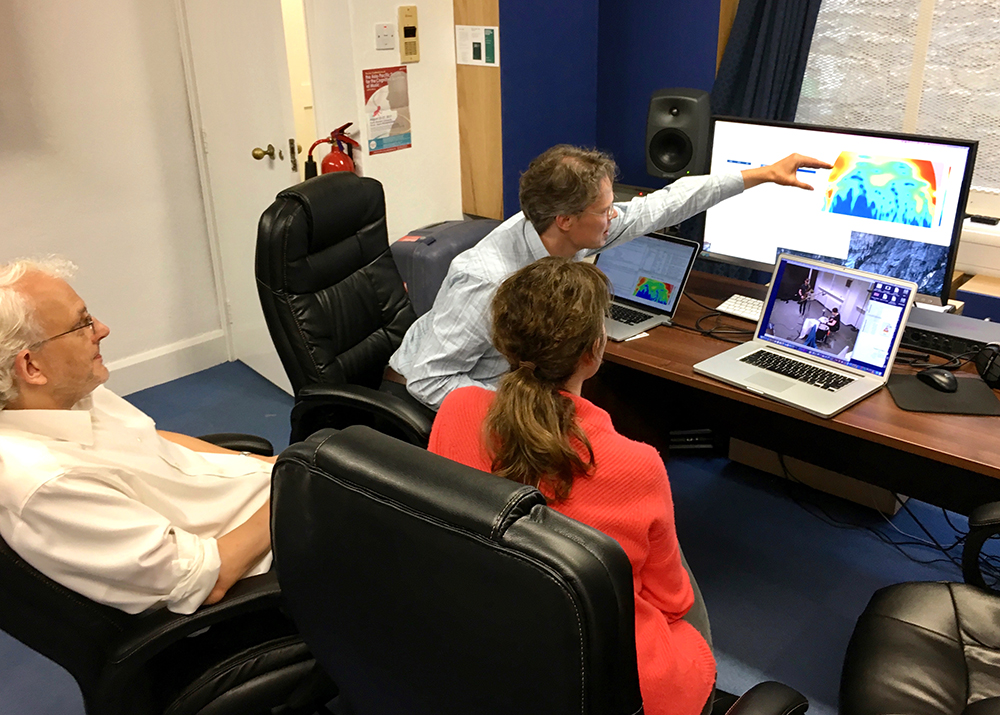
272 426 805 715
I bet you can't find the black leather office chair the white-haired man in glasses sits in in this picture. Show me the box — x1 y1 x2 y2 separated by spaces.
0 434 336 715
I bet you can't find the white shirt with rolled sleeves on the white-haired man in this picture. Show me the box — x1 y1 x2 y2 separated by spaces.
0 387 271 613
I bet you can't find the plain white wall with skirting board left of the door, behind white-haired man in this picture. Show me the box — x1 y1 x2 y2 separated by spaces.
0 0 226 392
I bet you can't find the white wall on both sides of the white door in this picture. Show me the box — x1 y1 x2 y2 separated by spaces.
0 0 461 394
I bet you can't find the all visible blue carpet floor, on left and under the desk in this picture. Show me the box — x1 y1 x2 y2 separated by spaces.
0 363 980 715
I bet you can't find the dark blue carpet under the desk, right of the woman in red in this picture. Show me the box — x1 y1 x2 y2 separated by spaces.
667 457 967 715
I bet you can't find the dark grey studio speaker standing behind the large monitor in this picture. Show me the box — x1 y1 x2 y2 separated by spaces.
646 89 712 179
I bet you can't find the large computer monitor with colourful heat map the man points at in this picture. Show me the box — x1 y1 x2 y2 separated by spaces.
702 117 978 304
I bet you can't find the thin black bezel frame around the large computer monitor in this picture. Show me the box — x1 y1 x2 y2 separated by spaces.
699 115 979 305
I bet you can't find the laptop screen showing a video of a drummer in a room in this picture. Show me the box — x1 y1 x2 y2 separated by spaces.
757 256 913 377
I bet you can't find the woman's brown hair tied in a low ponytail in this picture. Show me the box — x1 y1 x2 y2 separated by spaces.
485 257 611 501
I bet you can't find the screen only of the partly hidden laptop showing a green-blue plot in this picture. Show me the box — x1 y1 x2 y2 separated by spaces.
597 236 700 314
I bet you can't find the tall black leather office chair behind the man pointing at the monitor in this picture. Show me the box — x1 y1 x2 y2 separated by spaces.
256 172 433 445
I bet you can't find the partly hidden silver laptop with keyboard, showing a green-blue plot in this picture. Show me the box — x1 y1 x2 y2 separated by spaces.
595 236 701 340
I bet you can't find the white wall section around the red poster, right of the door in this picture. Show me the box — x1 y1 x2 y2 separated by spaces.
306 0 462 241
